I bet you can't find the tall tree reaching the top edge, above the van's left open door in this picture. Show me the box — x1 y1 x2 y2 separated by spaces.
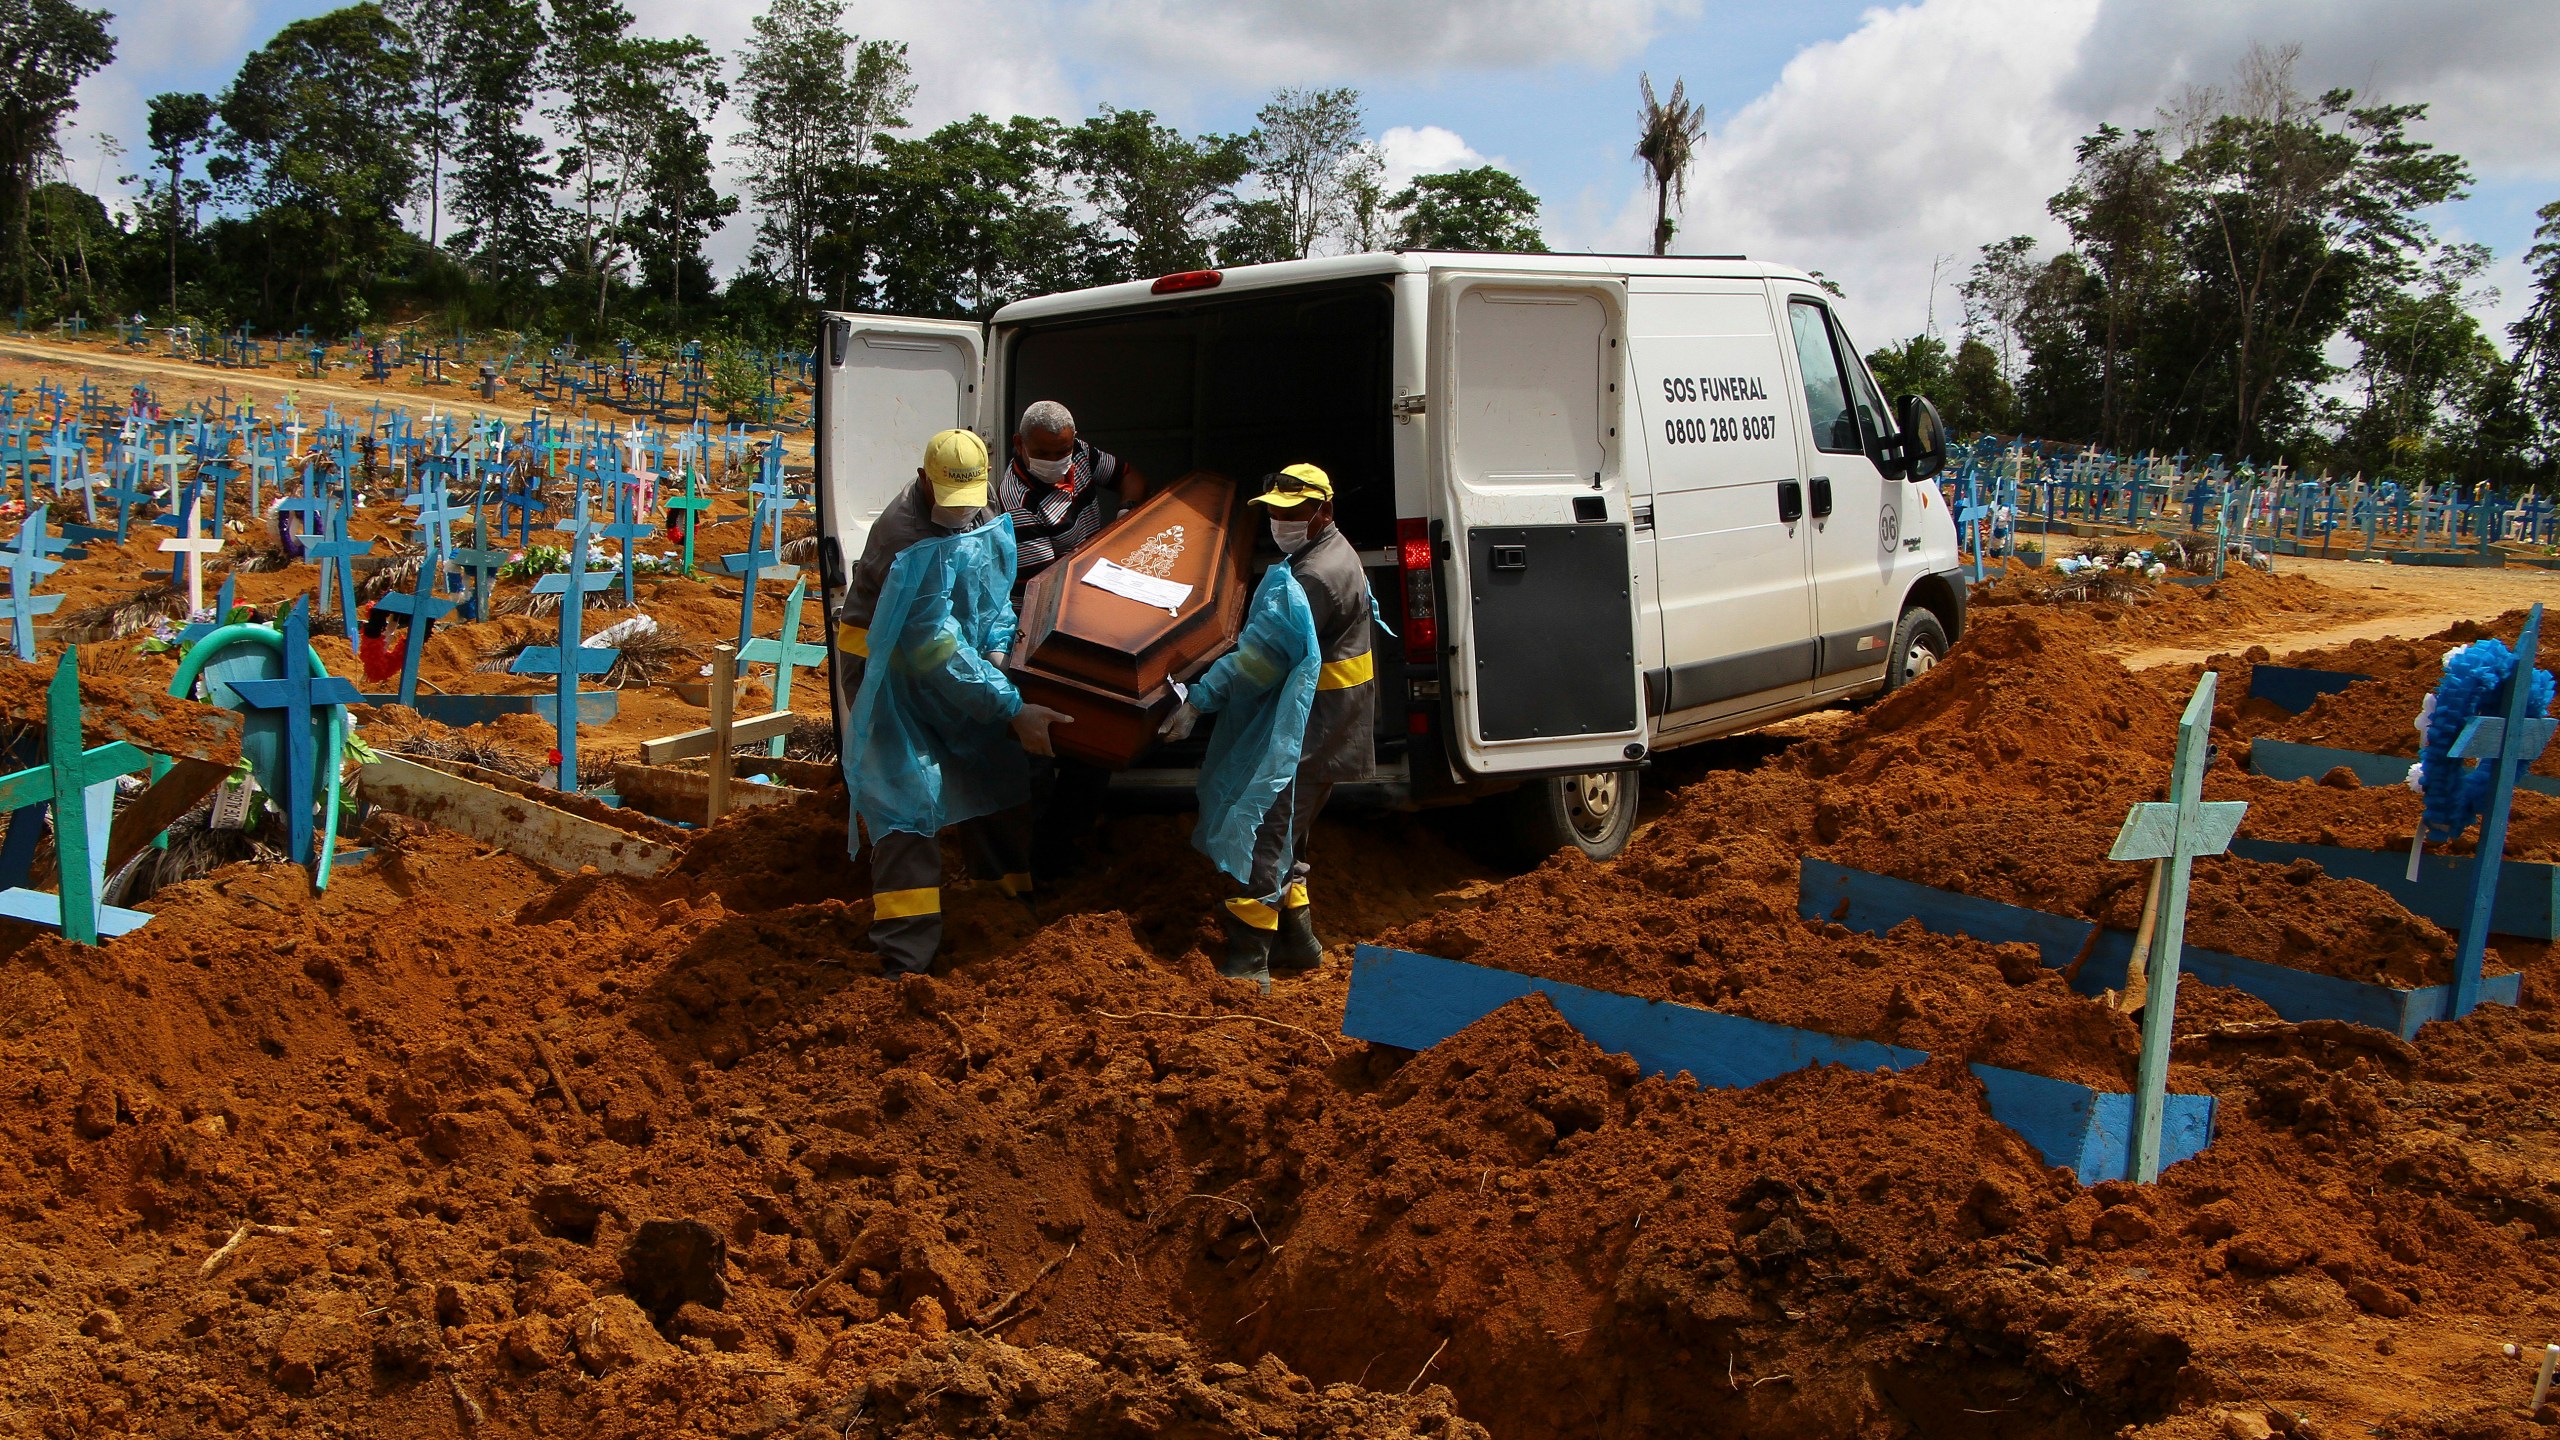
737 0 916 295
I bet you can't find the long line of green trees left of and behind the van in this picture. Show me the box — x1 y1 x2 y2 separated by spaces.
0 0 1544 338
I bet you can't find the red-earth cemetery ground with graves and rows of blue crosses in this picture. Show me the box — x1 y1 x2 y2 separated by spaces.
0 333 2560 1440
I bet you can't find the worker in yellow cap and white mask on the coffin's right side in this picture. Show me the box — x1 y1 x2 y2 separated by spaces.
1162 464 1377 989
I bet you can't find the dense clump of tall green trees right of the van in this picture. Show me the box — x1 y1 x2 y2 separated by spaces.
1869 49 2560 484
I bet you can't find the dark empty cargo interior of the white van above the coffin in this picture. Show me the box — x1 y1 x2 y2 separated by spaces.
1004 279 1395 548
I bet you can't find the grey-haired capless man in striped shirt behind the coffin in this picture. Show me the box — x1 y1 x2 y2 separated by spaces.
996 400 1147 881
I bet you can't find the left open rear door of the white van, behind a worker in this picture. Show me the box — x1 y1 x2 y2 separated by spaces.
817 315 986 730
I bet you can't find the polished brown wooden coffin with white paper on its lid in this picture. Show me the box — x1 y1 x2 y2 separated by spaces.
1009 471 1254 769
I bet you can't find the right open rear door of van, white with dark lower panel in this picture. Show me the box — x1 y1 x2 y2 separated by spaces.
1428 272 1644 774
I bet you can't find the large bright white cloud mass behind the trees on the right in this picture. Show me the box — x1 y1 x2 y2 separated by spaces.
1638 0 2560 343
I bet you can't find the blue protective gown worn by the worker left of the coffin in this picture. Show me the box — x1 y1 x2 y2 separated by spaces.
847 515 1032 835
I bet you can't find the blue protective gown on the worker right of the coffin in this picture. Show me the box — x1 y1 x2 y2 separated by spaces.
1190 564 1324 884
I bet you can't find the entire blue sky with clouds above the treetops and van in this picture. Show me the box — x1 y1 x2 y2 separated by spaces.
67 0 2560 343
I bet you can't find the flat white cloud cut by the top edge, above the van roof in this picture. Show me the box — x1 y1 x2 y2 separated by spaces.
1068 0 1700 85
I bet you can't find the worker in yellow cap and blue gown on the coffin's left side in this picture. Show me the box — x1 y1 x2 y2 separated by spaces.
835 420 1065 974
